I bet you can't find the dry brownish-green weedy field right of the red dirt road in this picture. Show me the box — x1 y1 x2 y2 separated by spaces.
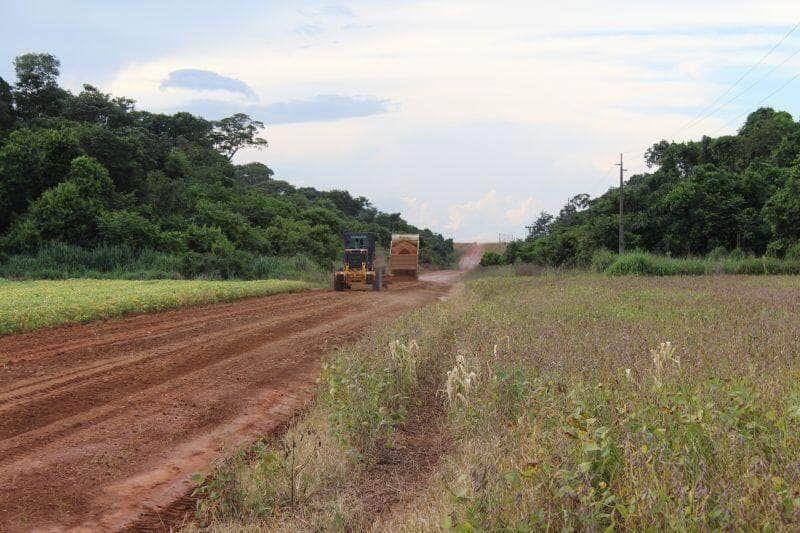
191 272 800 531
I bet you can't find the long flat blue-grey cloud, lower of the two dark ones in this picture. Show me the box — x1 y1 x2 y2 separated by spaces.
180 94 398 124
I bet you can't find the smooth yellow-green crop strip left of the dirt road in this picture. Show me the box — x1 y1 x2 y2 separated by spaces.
0 279 316 334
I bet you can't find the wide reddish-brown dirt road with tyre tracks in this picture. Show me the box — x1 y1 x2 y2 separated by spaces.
0 243 480 531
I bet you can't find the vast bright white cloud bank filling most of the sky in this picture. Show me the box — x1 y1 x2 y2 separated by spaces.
103 0 800 238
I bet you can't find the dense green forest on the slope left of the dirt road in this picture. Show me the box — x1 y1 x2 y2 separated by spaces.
0 54 454 277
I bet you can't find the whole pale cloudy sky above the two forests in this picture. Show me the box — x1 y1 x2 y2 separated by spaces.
0 0 800 241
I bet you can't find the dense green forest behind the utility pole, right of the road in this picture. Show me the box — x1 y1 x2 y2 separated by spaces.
506 108 800 266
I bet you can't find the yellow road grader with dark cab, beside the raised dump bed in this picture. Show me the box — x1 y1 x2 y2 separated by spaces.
333 232 386 291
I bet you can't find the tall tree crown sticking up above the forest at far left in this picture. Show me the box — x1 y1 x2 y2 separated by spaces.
14 54 68 120
